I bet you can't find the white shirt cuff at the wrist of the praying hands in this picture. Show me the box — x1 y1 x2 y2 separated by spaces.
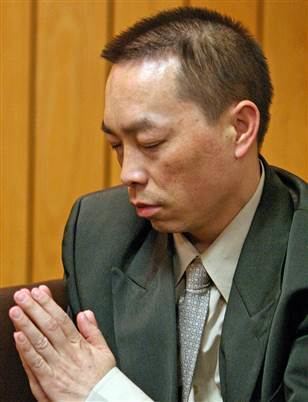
85 367 153 402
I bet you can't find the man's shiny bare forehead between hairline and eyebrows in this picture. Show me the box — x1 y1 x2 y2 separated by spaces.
104 57 185 123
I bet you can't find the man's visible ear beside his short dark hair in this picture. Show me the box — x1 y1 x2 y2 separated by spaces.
231 100 260 159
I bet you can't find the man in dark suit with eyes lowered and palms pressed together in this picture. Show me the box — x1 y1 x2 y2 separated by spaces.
10 8 308 402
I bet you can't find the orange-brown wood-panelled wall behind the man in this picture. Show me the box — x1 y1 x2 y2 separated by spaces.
0 0 308 286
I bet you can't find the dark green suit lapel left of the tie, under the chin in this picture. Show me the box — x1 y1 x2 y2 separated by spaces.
112 231 177 402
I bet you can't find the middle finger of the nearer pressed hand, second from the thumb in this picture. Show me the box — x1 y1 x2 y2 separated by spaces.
14 290 65 346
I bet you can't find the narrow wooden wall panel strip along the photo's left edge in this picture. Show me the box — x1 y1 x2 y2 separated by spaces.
0 0 32 286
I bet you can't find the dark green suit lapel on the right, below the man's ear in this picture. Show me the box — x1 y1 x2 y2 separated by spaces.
220 167 293 402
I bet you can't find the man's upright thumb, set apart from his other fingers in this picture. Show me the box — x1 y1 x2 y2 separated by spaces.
77 310 109 349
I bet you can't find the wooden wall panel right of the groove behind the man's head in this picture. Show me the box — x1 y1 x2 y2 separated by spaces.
263 0 308 180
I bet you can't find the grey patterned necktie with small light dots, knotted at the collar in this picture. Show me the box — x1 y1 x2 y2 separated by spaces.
178 257 211 402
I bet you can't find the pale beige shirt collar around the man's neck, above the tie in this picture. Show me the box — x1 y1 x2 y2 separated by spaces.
173 162 265 302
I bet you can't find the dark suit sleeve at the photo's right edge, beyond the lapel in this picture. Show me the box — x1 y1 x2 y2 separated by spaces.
284 209 308 402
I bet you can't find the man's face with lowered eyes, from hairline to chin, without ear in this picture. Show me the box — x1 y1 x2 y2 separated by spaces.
103 58 238 243
